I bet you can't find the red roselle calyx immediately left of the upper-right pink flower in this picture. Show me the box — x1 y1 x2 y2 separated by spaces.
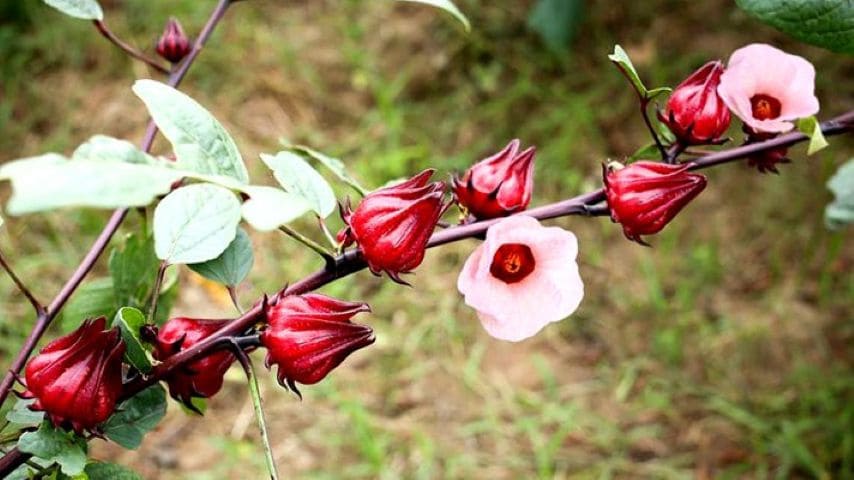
659 60 730 145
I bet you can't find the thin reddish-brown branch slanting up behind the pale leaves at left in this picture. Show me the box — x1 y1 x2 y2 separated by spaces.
0 0 233 412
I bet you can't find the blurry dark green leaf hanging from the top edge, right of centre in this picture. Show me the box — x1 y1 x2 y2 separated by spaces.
528 0 584 53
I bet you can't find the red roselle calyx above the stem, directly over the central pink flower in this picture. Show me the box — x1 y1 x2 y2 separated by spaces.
453 140 536 220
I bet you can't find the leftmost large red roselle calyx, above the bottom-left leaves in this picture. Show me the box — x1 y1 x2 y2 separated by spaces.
22 317 125 434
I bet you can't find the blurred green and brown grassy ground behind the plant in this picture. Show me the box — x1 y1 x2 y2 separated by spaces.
0 0 854 479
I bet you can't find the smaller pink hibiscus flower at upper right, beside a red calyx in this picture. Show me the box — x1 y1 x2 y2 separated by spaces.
718 43 818 133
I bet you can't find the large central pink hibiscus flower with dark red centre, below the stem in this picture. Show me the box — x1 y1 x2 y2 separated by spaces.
457 215 584 342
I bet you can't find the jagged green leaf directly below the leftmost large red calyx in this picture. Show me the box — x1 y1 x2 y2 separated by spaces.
18 421 86 476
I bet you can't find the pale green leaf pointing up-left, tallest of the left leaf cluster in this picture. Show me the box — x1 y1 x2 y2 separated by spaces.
133 80 249 184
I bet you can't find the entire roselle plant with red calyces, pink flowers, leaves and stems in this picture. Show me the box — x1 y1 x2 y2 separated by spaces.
0 0 854 479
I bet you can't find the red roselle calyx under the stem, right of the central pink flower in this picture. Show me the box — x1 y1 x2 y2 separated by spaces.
603 162 706 245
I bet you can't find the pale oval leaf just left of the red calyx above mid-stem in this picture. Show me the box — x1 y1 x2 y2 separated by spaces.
261 152 338 218
